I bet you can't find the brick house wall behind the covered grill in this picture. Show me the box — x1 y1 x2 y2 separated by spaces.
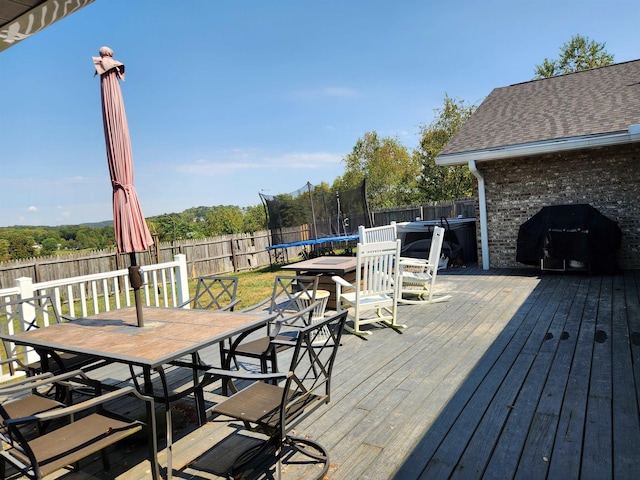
475 143 640 269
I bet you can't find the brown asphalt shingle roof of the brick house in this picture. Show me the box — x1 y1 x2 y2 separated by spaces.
440 60 640 155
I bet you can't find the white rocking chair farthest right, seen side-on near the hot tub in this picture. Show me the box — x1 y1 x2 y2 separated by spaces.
400 227 451 304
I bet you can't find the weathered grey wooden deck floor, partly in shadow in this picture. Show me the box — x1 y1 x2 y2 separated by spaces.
6 268 640 480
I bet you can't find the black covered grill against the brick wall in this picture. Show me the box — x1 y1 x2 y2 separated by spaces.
516 204 622 273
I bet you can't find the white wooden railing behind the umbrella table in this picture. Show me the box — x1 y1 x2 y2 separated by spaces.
0 254 189 382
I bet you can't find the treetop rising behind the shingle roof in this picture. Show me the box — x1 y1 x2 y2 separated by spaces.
535 35 613 78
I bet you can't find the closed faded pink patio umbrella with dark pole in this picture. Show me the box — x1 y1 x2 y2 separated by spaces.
93 47 153 327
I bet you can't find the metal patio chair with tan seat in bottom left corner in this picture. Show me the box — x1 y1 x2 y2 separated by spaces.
0 378 158 479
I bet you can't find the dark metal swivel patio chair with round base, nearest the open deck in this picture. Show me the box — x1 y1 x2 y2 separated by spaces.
211 312 347 479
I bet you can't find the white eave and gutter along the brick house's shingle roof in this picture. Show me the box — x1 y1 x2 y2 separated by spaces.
436 125 640 166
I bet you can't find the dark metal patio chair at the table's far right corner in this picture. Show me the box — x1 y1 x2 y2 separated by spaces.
220 275 319 373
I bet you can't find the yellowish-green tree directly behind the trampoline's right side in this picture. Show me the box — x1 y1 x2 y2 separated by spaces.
333 131 420 209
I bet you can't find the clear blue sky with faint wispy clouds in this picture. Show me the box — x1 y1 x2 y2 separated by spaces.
0 0 640 226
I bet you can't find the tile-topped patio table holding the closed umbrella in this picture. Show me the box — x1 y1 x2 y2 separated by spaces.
0 307 271 479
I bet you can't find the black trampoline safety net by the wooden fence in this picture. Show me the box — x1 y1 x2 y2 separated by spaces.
259 180 372 245
